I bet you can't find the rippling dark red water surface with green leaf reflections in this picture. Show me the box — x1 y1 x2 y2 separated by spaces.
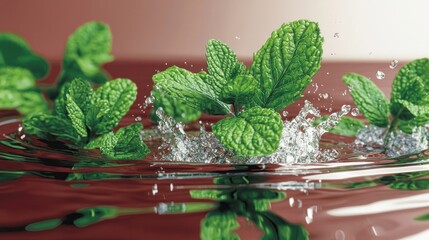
0 61 429 240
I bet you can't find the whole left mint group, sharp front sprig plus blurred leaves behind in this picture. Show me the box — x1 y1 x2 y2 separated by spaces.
0 21 149 159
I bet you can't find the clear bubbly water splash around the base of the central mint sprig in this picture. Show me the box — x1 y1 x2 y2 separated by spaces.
156 101 350 164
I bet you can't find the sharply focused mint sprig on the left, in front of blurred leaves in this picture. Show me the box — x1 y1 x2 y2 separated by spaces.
24 78 149 159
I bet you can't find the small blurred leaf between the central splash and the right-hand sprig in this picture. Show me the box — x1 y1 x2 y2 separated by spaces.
314 115 365 137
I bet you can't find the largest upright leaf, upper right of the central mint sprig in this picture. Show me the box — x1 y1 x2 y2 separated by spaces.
250 20 323 110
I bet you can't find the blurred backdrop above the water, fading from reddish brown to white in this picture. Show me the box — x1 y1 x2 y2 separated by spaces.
0 0 429 61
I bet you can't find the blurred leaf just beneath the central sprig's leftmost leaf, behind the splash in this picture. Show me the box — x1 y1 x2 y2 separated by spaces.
151 87 201 123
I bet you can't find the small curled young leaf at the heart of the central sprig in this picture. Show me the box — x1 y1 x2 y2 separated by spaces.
220 75 259 105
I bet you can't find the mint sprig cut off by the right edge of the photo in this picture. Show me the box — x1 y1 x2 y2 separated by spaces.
343 58 429 138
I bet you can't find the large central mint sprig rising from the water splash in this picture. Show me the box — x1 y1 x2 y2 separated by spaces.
153 20 323 156
